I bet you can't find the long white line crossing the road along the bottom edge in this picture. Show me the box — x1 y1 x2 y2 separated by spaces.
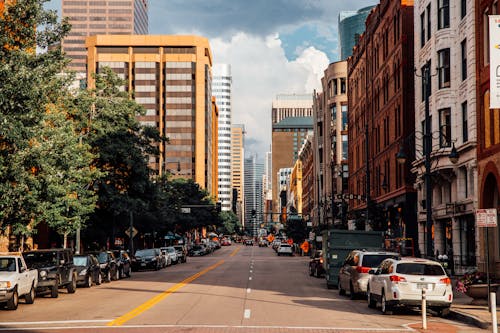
0 320 417 332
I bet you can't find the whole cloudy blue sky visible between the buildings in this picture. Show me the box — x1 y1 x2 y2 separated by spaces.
47 0 378 160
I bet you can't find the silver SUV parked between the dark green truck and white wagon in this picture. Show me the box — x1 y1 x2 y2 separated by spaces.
338 250 400 299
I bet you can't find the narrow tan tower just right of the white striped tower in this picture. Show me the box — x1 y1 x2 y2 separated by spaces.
231 124 245 226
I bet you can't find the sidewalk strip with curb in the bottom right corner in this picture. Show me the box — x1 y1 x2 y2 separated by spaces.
449 287 499 328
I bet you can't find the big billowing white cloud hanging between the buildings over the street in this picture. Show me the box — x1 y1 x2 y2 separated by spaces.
210 33 328 158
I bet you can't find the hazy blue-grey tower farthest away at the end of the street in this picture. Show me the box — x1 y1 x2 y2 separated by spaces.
244 156 264 236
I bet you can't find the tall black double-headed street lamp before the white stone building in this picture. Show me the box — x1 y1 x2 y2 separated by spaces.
396 65 459 257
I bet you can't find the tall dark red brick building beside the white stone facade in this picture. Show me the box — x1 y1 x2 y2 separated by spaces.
347 0 417 240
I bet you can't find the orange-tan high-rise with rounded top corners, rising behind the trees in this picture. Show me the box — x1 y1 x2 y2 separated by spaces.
86 35 218 198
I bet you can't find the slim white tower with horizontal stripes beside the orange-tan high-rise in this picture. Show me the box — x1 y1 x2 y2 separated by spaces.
212 64 232 211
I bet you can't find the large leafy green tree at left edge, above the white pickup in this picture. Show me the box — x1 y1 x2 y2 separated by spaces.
0 0 97 240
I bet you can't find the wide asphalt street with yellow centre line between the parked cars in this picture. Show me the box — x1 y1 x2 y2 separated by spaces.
0 245 481 333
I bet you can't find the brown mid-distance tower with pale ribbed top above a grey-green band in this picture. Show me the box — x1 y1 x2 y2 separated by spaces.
271 94 313 221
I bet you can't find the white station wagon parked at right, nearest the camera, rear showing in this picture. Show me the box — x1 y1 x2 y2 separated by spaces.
367 258 453 317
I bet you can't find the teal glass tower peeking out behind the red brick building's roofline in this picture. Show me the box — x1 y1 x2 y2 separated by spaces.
339 6 374 60
